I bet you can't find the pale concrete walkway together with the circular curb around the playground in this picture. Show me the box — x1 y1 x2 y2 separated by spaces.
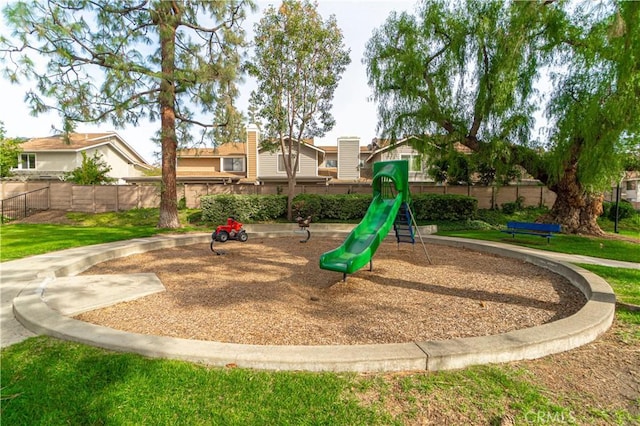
0 230 640 371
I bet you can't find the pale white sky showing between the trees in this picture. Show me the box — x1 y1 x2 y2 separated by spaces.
0 0 417 163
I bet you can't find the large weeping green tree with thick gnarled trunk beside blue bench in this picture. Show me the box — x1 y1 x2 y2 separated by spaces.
365 0 640 234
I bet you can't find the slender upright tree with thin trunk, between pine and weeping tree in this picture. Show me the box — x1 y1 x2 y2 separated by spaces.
248 0 351 220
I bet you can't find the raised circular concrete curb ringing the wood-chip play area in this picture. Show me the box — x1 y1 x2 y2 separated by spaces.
13 227 615 372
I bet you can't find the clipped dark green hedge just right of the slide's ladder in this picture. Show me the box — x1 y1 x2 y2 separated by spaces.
412 194 478 221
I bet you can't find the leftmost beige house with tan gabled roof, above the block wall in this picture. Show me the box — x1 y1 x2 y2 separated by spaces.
12 132 152 182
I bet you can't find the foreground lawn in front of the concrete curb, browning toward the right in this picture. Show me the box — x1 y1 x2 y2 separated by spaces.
0 337 640 426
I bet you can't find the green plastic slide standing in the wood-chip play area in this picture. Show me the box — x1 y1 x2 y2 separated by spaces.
320 160 409 277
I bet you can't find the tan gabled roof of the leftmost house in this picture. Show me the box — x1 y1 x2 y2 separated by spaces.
21 132 149 167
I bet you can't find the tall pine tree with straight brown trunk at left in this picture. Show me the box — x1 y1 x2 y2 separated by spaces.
0 0 251 228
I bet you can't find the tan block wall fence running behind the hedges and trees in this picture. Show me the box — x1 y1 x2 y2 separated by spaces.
0 181 556 213
